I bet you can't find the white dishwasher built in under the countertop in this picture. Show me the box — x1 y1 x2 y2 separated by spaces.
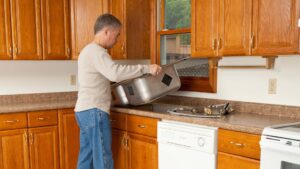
157 120 218 169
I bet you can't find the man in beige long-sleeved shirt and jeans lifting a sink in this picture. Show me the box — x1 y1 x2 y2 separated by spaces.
75 14 161 169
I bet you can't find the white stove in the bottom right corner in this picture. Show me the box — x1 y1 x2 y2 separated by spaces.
260 122 300 169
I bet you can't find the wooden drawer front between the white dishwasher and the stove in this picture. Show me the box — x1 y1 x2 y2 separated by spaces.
218 129 260 159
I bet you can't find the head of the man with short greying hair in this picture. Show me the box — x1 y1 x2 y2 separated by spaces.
94 14 122 49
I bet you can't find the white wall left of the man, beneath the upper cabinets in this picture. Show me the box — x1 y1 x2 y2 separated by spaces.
0 61 77 95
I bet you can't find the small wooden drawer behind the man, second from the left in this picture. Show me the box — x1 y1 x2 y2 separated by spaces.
28 110 58 127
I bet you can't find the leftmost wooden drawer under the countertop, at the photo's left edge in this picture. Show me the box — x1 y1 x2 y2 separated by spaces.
0 113 27 130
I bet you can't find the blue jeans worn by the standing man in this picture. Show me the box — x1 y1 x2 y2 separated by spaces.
75 108 114 169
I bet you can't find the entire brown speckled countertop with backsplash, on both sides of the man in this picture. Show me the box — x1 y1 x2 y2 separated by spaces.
0 92 300 134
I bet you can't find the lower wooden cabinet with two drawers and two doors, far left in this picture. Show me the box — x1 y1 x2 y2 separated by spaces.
0 110 59 169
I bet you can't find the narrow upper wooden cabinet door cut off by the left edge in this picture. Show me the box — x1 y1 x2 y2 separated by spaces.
0 0 12 60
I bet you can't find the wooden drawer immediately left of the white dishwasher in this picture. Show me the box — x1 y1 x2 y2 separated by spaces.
127 115 158 137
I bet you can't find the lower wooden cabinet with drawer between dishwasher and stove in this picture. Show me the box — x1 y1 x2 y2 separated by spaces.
218 129 260 169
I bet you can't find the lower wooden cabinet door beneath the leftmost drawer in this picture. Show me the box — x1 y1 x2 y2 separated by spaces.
0 129 29 169
